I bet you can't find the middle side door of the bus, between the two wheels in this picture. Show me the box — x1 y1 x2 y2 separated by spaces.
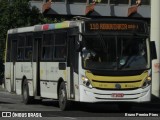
34 38 42 96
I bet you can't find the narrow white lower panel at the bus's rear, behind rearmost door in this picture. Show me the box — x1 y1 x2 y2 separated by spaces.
5 62 11 92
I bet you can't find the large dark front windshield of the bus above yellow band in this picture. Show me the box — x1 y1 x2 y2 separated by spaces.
82 35 150 70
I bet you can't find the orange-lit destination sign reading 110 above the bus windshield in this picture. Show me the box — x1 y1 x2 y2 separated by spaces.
85 21 146 33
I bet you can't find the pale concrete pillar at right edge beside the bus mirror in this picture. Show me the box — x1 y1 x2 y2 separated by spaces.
151 0 160 97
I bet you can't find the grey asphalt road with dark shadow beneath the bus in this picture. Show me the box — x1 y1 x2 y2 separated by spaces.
0 86 160 120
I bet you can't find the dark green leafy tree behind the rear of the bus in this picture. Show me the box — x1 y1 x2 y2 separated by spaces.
0 0 51 81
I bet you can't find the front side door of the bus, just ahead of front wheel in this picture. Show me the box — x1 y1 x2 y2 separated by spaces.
69 36 79 99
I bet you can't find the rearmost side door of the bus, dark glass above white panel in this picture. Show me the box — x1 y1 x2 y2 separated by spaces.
11 40 17 92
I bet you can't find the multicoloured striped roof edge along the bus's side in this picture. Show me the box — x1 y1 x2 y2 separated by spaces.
8 21 78 34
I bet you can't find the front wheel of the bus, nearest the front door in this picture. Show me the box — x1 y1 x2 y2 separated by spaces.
58 82 70 111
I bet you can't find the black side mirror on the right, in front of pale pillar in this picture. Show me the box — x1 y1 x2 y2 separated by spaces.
150 41 157 60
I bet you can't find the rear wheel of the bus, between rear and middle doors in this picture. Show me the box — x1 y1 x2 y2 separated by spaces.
22 80 33 104
